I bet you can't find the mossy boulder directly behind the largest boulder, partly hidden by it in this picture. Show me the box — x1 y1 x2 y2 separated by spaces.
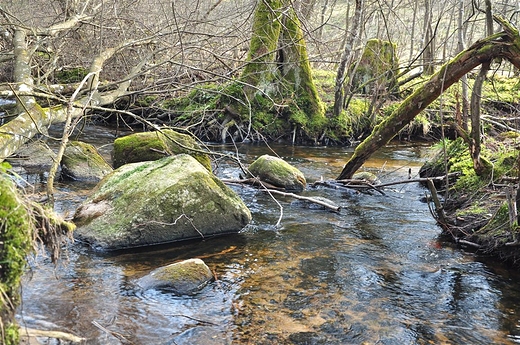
112 129 211 171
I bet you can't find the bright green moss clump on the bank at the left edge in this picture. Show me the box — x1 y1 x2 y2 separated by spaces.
0 172 33 345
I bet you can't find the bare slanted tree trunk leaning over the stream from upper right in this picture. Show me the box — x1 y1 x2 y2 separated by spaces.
337 16 520 180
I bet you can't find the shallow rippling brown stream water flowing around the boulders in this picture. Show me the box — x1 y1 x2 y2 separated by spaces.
12 127 520 345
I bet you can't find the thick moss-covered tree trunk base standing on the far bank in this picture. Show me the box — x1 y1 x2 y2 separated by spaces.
240 0 325 135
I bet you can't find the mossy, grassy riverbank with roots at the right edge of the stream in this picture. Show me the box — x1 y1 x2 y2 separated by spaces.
420 136 520 268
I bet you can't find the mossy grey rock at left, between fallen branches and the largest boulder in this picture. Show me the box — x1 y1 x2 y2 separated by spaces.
61 141 112 182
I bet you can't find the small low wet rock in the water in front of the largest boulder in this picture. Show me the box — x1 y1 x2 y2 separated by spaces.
138 259 213 295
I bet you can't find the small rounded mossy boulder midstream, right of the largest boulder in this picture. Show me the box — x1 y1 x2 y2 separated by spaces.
249 155 307 191
